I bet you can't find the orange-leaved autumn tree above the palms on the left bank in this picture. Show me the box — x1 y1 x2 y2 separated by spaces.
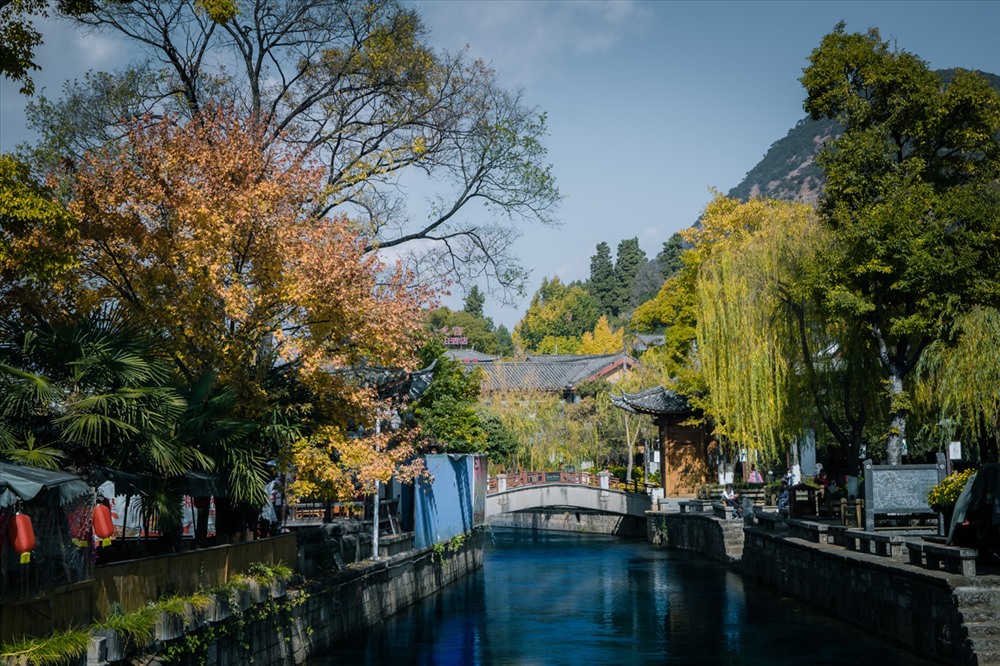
20 109 428 500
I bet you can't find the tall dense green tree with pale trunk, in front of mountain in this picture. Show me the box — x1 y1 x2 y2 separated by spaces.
802 23 1000 464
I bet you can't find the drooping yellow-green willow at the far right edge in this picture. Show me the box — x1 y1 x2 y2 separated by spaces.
914 308 1000 462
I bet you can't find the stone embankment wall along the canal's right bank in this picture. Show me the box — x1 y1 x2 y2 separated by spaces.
647 510 1000 666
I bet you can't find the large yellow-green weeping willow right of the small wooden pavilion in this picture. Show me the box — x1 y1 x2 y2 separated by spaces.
687 197 819 457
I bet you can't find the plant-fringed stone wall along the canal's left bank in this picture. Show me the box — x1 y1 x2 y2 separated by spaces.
87 531 483 666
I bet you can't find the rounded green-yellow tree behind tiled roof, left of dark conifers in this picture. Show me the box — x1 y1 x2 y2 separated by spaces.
514 278 600 353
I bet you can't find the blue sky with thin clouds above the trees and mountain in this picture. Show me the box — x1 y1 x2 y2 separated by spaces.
0 0 1000 329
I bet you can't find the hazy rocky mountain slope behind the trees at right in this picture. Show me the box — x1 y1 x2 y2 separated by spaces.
728 69 1000 203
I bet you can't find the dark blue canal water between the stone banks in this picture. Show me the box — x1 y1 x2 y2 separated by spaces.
316 531 932 666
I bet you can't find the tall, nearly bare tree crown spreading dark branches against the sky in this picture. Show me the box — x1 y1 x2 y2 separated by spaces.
27 0 559 290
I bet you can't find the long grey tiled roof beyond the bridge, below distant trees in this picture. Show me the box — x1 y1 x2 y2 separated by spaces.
479 353 636 391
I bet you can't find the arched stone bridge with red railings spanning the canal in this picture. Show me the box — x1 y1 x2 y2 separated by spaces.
486 472 652 534
